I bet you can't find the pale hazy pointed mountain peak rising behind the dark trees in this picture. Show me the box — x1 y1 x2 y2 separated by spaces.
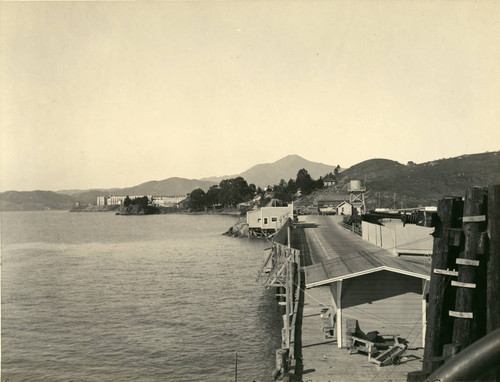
204 155 337 187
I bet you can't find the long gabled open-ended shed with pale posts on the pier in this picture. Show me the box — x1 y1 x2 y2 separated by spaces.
304 216 430 348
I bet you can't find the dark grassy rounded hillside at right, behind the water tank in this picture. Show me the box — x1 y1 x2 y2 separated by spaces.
300 151 500 209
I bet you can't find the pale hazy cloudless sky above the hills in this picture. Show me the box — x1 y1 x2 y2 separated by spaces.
0 0 500 191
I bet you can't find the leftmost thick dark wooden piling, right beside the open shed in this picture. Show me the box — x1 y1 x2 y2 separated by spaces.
422 197 463 374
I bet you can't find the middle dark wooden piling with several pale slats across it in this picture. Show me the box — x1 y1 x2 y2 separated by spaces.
452 187 487 350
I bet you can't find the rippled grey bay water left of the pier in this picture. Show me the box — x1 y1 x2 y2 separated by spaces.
1 212 281 382
